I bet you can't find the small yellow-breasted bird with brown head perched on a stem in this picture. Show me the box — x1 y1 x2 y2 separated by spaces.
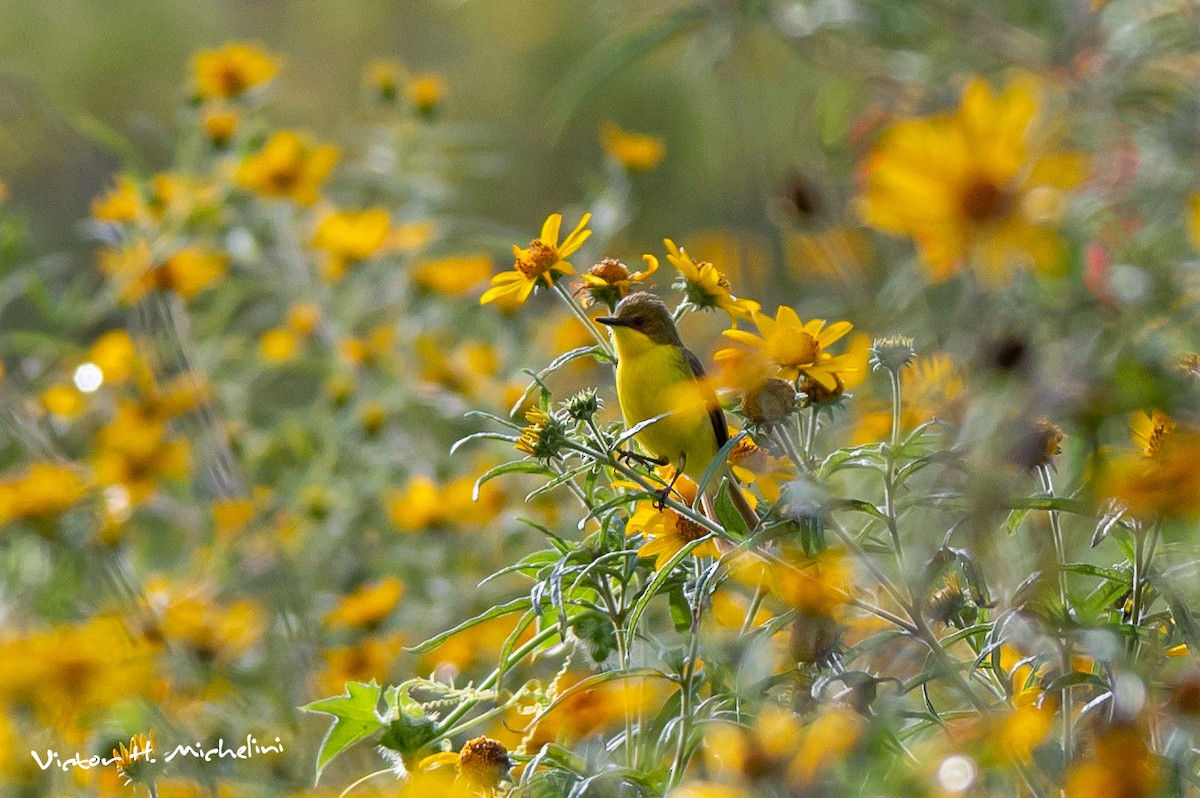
596 292 758 529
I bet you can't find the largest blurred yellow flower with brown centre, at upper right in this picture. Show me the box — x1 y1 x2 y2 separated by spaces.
860 74 1082 281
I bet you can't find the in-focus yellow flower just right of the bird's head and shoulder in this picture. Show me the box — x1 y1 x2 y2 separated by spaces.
715 306 857 390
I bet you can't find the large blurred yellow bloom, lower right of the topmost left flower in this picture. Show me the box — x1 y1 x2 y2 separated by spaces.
236 131 338 205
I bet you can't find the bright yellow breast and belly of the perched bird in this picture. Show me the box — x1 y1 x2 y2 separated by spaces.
614 328 718 479
